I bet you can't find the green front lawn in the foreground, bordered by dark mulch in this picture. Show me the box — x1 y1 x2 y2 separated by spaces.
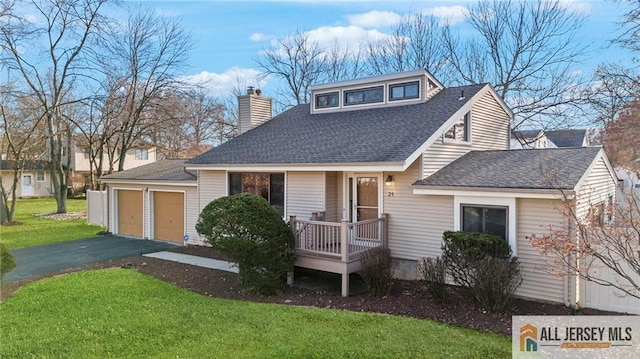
0 268 511 358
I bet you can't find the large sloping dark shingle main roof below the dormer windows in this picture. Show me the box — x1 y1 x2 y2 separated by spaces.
186 84 485 164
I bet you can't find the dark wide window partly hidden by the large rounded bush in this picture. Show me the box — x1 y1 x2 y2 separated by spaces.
229 173 284 216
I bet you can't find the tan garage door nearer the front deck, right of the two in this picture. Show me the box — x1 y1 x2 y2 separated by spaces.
153 192 184 243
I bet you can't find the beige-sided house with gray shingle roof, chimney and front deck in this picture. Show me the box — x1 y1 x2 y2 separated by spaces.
100 70 617 310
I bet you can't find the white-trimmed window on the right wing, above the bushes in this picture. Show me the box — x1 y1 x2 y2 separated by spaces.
461 205 509 240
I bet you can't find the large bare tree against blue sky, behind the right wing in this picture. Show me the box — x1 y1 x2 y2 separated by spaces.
443 0 585 129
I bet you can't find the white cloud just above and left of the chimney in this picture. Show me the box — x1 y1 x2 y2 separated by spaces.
182 67 265 97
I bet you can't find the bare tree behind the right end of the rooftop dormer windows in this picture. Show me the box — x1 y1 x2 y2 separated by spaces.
367 14 451 81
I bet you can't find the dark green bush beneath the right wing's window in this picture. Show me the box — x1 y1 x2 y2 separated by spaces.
442 231 522 312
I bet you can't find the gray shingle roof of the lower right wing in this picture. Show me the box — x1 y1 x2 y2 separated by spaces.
414 147 600 190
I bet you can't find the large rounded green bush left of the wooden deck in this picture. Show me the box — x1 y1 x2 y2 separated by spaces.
196 193 295 295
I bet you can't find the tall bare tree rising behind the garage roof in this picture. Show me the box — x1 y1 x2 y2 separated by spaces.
103 8 193 171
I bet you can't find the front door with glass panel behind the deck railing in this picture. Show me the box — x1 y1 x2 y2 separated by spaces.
349 175 380 222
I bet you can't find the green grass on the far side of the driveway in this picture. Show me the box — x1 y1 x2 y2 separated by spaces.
0 198 104 249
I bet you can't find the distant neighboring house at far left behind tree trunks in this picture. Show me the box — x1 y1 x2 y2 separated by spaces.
0 160 54 198
